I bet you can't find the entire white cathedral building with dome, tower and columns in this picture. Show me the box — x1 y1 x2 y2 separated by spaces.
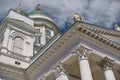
0 4 120 80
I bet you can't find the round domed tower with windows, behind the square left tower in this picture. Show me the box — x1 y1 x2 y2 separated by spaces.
28 4 58 46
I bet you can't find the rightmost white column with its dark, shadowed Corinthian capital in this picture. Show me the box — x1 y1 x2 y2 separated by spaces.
100 57 116 80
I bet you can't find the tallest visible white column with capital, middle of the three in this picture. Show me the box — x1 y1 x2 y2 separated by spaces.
77 45 93 80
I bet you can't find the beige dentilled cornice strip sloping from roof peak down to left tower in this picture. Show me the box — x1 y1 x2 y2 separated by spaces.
27 26 76 74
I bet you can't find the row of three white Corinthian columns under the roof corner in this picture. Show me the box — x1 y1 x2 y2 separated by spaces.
41 45 115 80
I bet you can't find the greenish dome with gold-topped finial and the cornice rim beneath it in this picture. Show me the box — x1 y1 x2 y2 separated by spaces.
28 4 59 34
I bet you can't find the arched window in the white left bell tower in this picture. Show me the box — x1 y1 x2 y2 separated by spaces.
13 36 24 54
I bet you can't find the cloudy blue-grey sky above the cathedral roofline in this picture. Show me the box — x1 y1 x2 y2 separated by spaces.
0 0 120 30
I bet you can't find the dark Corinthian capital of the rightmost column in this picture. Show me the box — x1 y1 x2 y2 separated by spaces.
98 57 114 70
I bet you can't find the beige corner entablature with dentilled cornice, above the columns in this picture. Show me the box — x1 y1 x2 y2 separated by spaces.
27 22 120 79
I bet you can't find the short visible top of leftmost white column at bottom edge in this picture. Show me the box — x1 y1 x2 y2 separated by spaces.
56 65 69 80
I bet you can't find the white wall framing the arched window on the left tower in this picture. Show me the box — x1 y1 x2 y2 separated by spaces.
1 21 34 57
